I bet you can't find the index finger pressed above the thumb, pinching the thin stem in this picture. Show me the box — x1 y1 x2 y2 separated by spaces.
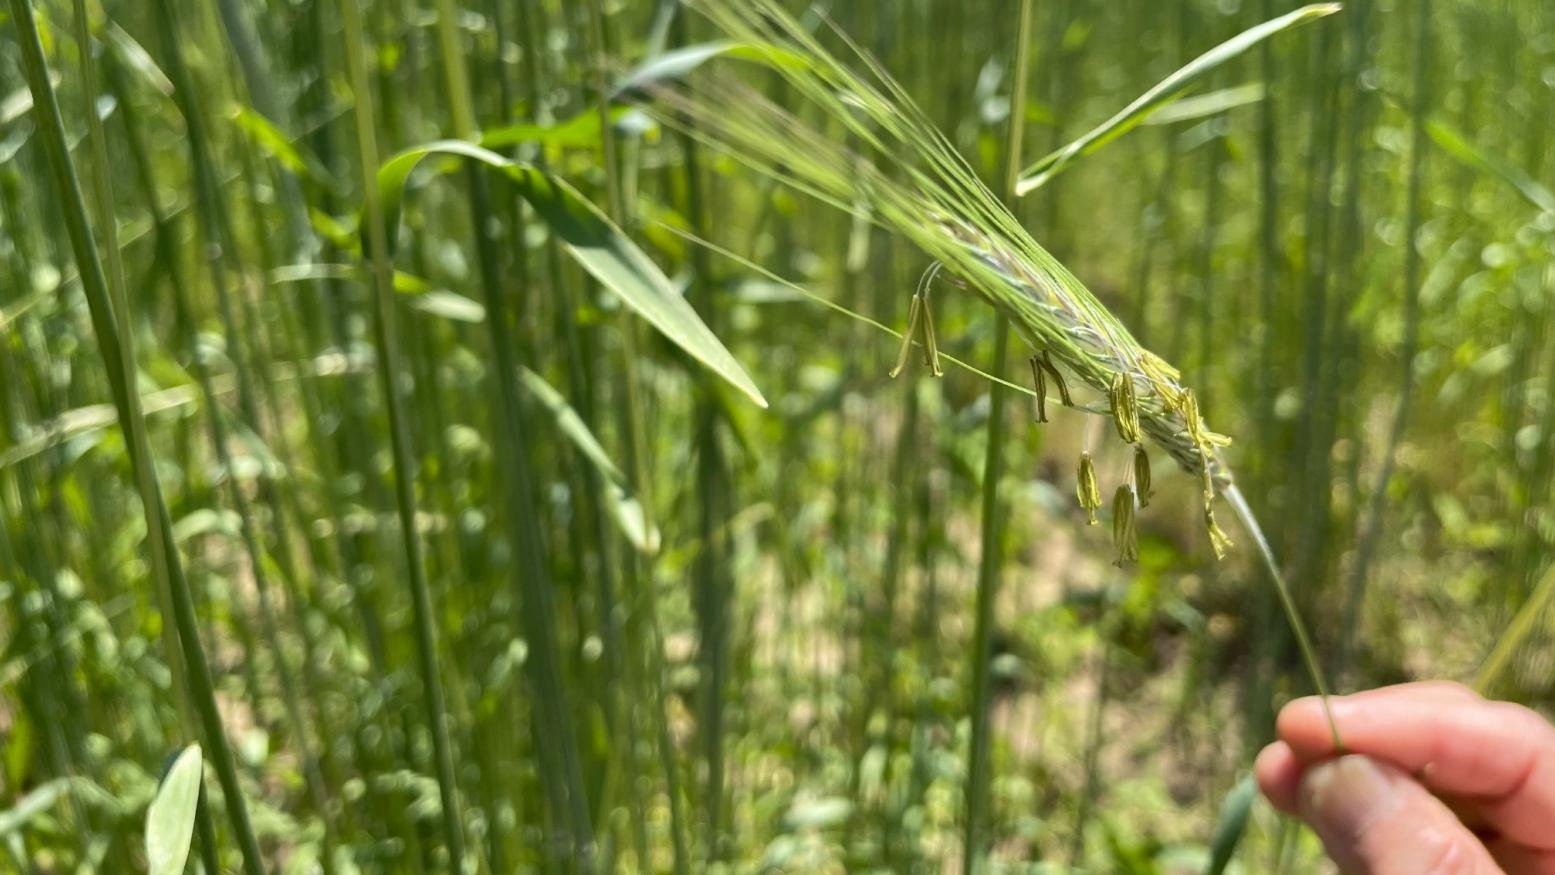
1277 685 1555 850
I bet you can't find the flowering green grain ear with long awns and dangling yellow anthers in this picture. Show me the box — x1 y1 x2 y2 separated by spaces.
671 0 1250 562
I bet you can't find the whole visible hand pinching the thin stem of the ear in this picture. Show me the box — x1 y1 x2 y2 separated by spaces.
1255 681 1555 875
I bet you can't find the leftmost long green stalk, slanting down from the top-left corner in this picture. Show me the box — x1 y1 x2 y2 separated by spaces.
11 0 263 875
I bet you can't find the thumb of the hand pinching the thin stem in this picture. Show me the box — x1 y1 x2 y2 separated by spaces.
1300 755 1501 875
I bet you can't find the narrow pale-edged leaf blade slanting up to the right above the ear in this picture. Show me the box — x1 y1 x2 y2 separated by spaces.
1015 3 1340 196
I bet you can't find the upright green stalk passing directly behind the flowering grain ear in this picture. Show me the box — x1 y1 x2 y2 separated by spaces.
961 0 1033 875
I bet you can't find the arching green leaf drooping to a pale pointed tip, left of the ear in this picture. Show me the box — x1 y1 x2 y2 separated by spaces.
378 140 767 407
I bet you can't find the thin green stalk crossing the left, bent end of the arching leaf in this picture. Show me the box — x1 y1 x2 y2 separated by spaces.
341 0 465 872
